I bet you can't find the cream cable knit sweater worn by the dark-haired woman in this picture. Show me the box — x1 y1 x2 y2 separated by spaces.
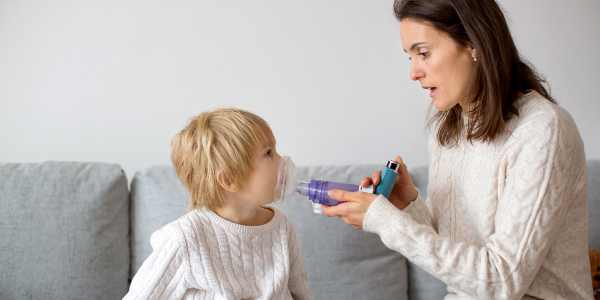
363 92 593 299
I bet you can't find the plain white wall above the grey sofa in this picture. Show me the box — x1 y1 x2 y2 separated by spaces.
0 0 600 178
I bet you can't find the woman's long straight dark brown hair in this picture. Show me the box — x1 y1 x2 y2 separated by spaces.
394 0 556 147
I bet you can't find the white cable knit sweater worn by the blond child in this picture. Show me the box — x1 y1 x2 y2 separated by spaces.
124 206 313 300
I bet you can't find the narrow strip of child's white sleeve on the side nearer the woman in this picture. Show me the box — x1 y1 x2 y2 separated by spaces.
288 221 314 300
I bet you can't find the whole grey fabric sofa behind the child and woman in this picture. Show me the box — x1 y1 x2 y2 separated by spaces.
0 161 600 300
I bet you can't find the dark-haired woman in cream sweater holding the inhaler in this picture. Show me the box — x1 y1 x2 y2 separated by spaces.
323 0 593 299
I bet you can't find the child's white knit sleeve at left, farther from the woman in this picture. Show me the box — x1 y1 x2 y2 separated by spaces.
123 223 192 300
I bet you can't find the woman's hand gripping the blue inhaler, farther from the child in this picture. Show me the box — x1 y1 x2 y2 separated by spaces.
360 156 418 210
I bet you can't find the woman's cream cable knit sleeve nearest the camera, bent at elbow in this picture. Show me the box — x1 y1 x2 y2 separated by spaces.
363 116 587 299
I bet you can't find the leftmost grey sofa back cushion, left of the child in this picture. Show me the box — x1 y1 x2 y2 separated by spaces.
0 162 130 299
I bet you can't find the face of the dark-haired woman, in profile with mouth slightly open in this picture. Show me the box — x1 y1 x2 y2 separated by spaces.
400 19 475 111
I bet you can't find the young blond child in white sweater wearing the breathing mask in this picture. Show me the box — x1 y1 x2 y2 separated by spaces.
124 108 313 299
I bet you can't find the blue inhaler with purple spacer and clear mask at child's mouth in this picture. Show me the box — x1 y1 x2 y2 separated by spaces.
274 156 399 214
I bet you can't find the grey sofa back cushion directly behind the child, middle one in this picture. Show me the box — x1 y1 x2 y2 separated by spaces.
131 166 407 300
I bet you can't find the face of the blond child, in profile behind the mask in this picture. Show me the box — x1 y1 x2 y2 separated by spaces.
238 141 281 206
